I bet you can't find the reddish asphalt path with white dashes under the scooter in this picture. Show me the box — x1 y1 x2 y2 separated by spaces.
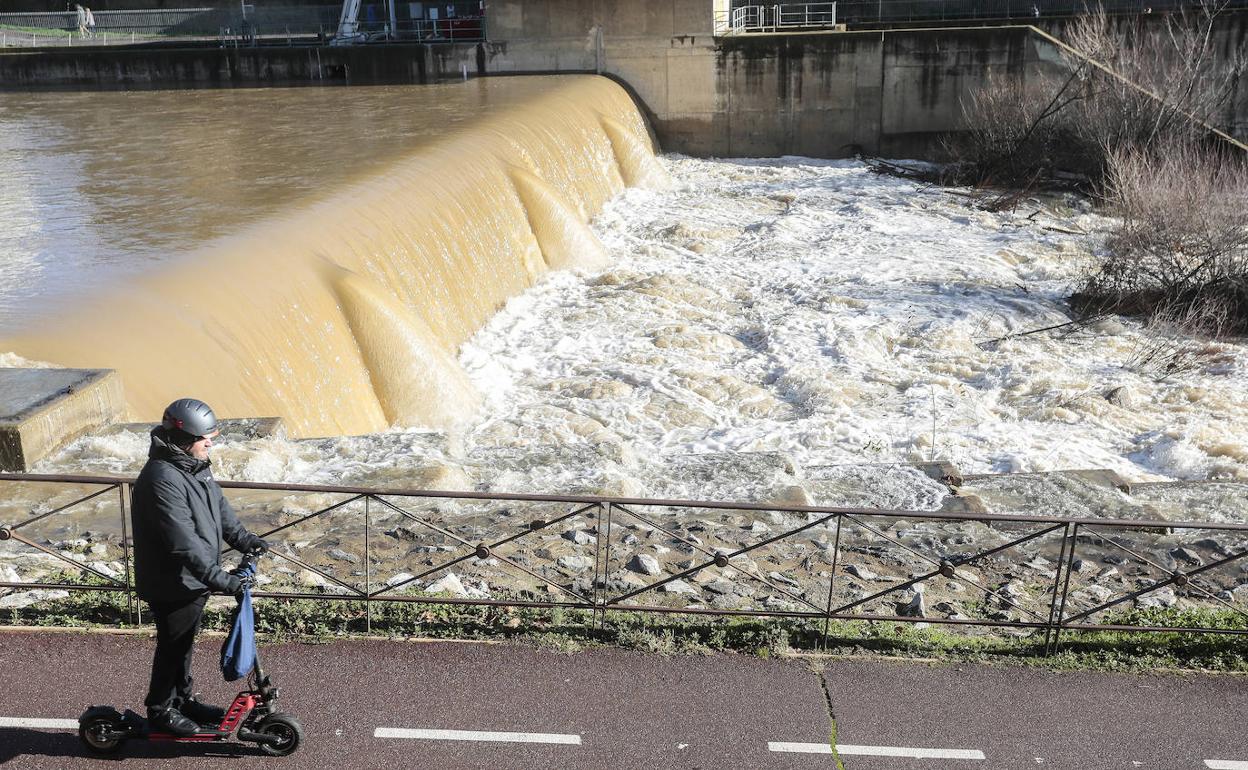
0 631 1248 770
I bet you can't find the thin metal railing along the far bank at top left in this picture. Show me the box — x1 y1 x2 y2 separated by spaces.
0 5 485 47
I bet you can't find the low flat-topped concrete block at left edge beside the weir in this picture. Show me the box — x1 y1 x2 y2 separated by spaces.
0 368 126 472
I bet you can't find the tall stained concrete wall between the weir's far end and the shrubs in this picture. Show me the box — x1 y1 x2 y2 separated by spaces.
485 0 1056 157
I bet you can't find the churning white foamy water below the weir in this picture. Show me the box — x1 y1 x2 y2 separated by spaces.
39 156 1248 508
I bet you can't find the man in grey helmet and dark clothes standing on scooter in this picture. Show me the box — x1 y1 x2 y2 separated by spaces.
131 398 268 736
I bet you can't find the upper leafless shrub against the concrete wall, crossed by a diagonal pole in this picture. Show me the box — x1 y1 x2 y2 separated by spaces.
946 0 1248 190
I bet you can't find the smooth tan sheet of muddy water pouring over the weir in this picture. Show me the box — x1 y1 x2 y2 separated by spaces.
0 76 665 436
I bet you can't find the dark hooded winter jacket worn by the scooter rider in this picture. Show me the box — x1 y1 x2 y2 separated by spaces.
130 427 261 602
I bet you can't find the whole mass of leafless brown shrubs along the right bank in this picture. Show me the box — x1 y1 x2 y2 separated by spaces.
948 0 1248 334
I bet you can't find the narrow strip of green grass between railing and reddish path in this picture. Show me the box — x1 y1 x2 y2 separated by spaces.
0 575 1248 673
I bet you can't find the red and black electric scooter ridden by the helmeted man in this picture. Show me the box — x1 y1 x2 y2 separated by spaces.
79 555 303 756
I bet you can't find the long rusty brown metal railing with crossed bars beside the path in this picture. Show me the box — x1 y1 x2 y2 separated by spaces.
0 474 1248 651
